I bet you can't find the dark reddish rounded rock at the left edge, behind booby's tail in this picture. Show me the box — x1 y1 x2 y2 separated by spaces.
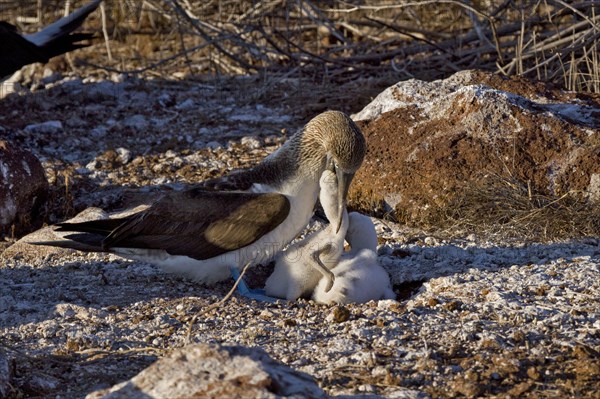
0 141 48 235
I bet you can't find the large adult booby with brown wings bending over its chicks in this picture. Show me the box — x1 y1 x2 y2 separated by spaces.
37 111 366 290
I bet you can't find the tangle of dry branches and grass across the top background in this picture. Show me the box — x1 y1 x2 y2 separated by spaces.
1 0 600 92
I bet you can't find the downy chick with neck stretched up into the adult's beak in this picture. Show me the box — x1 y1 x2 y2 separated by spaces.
265 170 348 301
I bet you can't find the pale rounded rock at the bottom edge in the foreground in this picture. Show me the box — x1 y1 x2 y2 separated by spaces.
87 344 326 399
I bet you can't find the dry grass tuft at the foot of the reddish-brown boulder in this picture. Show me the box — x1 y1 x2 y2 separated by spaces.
436 175 600 241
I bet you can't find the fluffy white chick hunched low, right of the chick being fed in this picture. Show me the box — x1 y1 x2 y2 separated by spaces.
312 212 396 304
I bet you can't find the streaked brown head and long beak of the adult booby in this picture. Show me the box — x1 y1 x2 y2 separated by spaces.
305 111 367 233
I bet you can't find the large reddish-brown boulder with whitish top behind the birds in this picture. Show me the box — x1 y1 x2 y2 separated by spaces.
350 71 600 230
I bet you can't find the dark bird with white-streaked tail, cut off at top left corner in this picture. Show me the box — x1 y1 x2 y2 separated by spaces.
0 0 102 79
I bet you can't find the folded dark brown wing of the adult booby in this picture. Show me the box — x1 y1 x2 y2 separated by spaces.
85 188 290 260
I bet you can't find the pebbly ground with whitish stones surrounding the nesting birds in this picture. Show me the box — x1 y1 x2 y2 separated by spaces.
0 70 600 398
